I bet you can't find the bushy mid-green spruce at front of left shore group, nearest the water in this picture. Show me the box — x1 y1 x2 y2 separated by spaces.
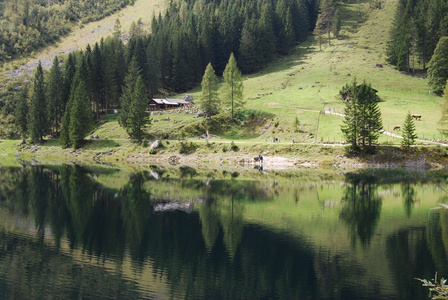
68 81 93 149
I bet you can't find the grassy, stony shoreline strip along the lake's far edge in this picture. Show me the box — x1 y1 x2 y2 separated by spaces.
0 140 448 172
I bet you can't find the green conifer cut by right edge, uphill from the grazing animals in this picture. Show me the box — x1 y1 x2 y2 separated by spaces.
428 36 448 94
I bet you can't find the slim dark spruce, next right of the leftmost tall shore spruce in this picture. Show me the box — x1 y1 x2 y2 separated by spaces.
46 56 65 136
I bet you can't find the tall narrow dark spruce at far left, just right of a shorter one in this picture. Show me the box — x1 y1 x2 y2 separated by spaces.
29 61 48 142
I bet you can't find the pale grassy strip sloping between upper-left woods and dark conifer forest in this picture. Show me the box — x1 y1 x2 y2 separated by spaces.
6 0 165 78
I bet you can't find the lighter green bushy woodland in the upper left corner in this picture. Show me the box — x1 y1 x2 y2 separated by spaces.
0 0 134 64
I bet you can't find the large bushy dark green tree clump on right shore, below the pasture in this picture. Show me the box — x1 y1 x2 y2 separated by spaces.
340 79 383 152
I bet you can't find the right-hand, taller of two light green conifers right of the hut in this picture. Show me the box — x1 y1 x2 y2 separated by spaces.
223 53 244 121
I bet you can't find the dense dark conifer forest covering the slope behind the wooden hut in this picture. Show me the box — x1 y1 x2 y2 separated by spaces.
0 0 318 140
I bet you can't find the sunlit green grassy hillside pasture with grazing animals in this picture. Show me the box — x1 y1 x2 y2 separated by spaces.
82 0 443 144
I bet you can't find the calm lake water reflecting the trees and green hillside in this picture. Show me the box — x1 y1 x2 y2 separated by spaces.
0 165 448 299
